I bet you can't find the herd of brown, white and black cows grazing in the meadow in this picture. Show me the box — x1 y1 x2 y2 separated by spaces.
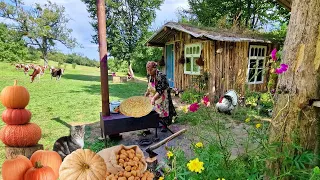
15 64 64 83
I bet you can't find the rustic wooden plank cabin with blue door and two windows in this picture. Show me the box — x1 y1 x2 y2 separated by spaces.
146 22 275 98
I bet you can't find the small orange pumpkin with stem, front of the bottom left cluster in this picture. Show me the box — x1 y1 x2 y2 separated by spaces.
24 162 57 180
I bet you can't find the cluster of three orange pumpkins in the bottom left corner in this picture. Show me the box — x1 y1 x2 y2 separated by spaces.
2 150 62 180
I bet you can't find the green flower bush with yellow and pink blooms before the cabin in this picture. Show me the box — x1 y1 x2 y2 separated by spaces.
161 50 320 180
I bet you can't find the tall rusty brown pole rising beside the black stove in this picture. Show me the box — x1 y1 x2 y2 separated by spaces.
97 0 110 116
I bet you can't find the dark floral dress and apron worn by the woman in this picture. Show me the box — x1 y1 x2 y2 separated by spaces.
148 70 177 125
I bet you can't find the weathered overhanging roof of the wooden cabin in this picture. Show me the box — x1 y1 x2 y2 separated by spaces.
146 22 278 47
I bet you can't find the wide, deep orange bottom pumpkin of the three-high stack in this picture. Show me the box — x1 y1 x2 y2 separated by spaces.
0 123 41 147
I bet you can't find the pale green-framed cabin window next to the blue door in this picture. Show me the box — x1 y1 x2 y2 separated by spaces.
184 43 201 75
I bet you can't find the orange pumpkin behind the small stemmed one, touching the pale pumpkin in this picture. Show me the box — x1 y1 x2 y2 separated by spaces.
30 150 62 179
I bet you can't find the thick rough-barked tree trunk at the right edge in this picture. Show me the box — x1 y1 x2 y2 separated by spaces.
268 0 320 175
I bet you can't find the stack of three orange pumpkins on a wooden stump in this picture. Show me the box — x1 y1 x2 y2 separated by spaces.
0 80 41 147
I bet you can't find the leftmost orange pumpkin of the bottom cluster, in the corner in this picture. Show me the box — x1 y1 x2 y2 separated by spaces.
2 155 32 180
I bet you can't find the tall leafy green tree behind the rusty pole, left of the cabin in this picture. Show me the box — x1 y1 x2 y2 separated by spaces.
82 0 163 78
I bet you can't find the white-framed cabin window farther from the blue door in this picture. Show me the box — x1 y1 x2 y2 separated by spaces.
247 45 267 84
